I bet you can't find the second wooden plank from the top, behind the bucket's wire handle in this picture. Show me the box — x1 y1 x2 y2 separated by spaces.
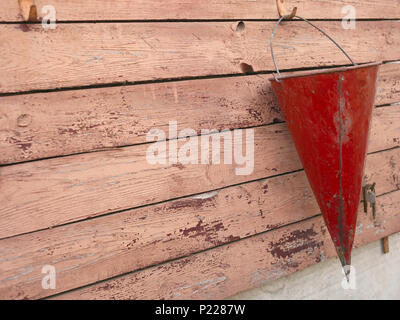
0 20 400 93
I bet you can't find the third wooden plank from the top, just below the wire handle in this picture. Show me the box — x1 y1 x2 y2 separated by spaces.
0 63 400 163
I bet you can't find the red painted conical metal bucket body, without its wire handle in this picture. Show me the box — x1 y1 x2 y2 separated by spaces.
270 63 379 266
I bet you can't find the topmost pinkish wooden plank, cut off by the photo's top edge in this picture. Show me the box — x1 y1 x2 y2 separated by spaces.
0 0 400 21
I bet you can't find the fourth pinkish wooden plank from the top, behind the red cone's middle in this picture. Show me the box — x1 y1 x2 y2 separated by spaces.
0 106 399 238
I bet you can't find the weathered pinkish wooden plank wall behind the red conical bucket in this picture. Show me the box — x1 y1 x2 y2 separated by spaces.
0 0 400 299
